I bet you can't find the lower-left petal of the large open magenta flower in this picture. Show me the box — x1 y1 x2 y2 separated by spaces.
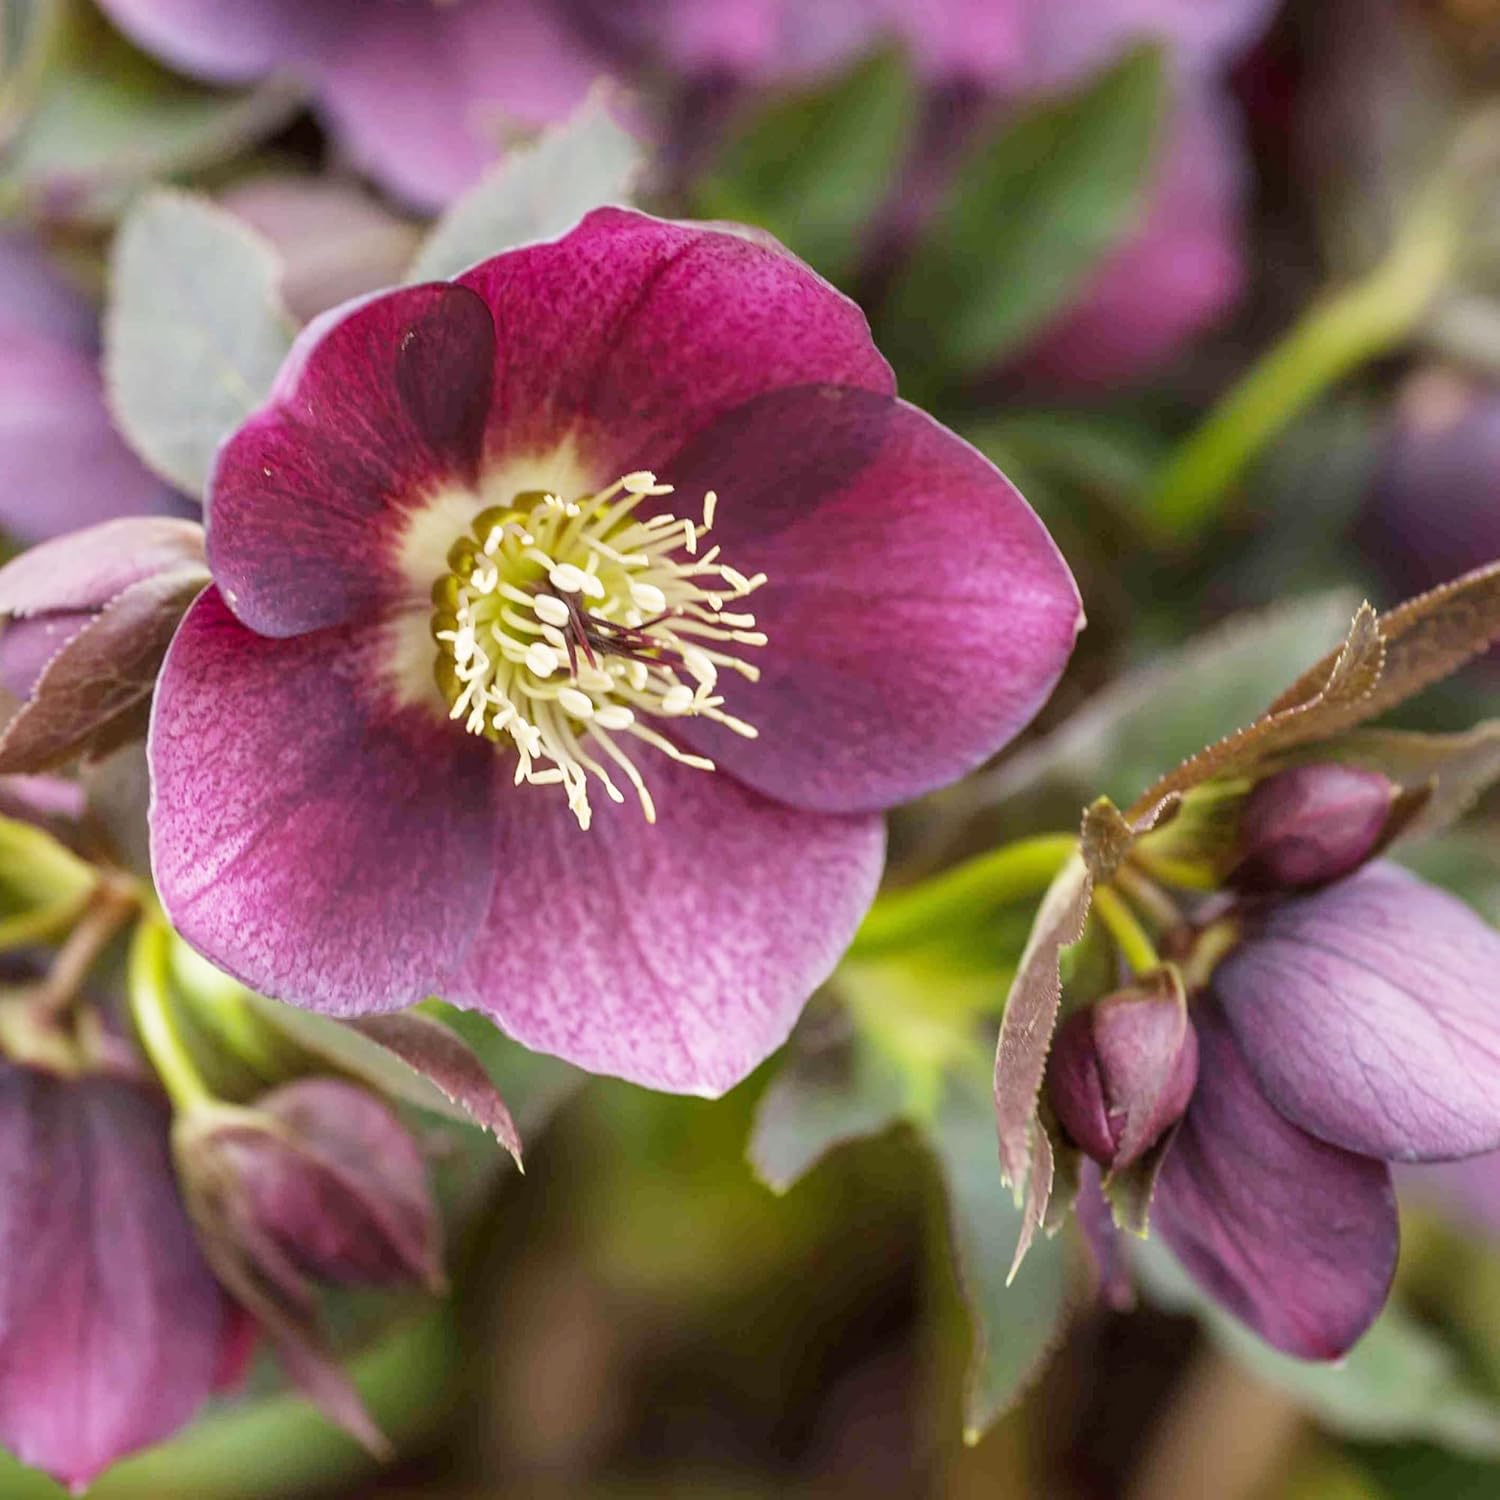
149 590 494 1016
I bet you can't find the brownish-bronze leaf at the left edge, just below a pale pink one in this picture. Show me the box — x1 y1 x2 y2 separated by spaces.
0 564 209 774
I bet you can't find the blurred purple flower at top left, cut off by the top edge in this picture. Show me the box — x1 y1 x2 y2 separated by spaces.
95 0 599 209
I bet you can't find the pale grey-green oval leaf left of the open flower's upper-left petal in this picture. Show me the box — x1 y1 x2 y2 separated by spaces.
105 189 293 497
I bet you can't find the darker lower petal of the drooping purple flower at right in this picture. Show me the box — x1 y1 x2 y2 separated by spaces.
1152 1001 1400 1359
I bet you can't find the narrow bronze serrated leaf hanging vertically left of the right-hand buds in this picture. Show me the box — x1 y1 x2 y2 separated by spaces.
995 854 1094 1200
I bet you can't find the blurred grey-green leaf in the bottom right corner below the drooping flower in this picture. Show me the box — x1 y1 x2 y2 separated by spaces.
1133 1241 1500 1454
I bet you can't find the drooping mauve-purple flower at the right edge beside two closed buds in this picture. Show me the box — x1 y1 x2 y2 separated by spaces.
1152 863 1500 1359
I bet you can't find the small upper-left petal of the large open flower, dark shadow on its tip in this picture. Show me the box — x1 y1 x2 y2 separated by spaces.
209 282 495 636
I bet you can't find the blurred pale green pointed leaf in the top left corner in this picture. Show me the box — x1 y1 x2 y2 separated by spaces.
0 3 300 224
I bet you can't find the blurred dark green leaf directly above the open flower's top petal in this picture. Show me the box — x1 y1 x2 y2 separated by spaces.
696 53 917 282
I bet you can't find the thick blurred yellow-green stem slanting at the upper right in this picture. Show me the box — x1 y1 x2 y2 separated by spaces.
1146 210 1458 537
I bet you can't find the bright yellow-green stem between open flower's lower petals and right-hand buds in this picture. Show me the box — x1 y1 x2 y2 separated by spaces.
849 834 1079 957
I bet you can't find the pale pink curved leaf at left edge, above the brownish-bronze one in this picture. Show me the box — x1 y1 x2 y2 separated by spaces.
0 516 207 615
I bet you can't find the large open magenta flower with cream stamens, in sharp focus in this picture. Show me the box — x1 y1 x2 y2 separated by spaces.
150 210 1082 1094
